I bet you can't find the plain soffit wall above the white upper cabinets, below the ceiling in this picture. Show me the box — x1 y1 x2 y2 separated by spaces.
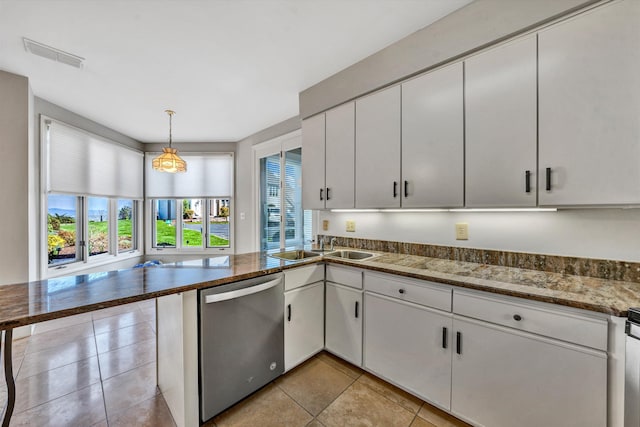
300 0 599 119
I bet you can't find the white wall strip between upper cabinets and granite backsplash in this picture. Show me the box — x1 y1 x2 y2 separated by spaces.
319 209 640 262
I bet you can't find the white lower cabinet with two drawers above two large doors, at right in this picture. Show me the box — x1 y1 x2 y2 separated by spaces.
362 271 608 427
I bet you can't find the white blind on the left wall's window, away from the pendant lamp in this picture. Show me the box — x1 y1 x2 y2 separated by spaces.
44 119 143 199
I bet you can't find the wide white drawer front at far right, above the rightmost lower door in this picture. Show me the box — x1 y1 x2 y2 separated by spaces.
453 289 608 351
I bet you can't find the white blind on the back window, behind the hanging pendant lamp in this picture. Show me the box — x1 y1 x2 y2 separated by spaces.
145 153 233 198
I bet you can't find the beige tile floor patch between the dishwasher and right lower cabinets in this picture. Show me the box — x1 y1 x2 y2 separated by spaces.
206 352 468 427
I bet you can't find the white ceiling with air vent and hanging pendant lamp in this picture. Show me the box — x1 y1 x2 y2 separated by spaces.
0 0 471 142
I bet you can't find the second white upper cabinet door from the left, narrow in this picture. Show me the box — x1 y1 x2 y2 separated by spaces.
325 102 356 209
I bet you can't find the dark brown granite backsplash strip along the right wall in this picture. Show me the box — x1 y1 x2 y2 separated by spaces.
318 234 640 282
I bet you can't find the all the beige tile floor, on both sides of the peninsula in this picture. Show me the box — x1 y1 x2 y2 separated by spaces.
0 301 466 427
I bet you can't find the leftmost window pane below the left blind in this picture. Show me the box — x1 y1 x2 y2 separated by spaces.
47 194 82 266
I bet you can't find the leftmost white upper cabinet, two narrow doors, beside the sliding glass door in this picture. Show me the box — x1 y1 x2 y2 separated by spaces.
302 102 355 209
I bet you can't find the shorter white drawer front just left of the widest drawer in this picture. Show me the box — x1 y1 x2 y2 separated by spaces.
364 271 452 311
